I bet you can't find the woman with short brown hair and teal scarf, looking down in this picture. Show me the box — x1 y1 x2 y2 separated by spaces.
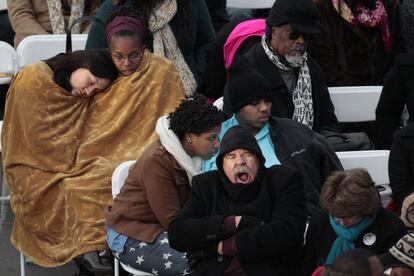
303 169 407 275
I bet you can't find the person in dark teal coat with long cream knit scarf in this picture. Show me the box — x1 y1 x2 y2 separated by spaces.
86 0 215 95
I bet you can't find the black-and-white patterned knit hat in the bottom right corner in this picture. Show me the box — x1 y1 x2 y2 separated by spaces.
380 233 414 269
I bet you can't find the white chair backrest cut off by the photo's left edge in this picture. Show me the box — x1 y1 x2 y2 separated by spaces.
0 41 17 84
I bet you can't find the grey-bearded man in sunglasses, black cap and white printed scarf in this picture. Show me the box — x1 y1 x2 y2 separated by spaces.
239 0 338 135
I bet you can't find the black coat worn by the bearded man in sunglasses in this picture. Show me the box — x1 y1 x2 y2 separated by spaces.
245 43 338 132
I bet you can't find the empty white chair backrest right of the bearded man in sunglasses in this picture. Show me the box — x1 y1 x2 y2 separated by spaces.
328 86 382 123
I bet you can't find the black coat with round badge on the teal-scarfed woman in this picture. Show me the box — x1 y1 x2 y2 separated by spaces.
304 207 407 275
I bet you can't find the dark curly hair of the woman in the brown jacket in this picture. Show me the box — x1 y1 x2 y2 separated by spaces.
168 95 224 141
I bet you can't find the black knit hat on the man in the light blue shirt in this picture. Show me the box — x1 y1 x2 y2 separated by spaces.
223 57 271 113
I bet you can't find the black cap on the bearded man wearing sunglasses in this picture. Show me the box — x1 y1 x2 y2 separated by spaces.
266 0 319 34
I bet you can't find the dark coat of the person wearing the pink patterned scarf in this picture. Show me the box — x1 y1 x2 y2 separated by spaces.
309 0 403 86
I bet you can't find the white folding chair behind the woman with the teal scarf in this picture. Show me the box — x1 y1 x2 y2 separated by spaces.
336 150 392 206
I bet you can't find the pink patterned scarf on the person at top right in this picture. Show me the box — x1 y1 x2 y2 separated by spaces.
331 0 391 53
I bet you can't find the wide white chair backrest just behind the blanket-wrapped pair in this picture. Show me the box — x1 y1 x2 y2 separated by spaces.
17 34 88 68
